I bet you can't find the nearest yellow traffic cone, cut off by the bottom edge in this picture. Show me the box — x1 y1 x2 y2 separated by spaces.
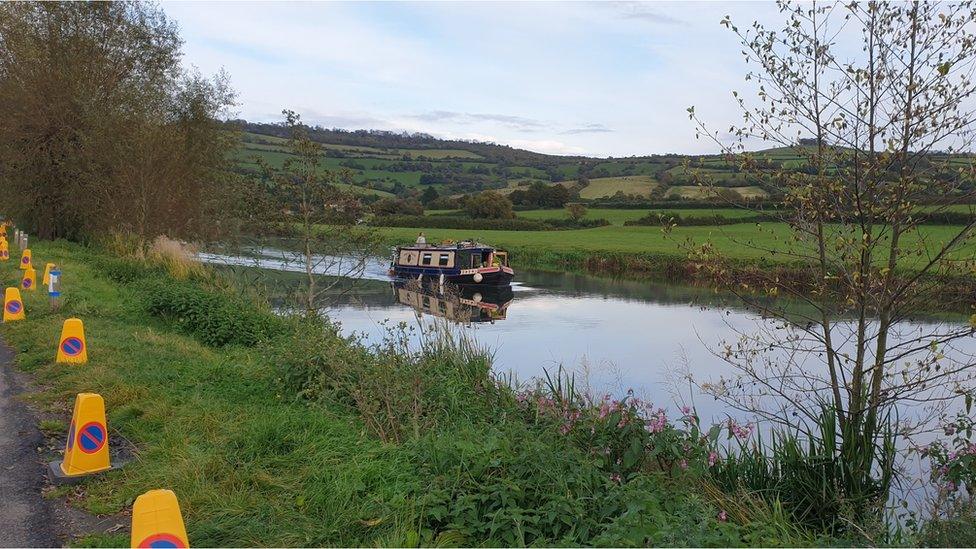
129 490 190 547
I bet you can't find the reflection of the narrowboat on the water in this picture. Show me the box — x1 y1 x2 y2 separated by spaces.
392 280 514 324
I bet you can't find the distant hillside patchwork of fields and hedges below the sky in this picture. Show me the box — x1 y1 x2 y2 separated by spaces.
229 120 971 201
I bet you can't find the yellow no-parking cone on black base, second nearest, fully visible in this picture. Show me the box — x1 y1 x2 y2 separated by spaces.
49 393 112 484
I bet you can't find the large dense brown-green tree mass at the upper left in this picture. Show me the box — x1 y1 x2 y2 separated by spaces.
0 2 234 240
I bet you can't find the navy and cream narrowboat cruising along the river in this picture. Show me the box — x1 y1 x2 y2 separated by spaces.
390 240 515 286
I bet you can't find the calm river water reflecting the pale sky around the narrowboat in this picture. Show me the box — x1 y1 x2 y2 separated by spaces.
202 250 976 432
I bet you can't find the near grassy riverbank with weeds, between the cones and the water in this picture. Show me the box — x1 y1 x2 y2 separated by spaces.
3 238 812 546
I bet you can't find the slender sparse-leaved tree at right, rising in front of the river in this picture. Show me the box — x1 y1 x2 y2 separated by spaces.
689 3 976 512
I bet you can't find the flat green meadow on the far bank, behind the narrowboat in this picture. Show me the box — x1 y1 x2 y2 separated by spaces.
378 223 976 313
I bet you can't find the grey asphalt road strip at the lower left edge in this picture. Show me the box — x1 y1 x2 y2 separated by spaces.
0 342 60 547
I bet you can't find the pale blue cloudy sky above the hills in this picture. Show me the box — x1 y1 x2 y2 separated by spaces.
161 1 780 157
